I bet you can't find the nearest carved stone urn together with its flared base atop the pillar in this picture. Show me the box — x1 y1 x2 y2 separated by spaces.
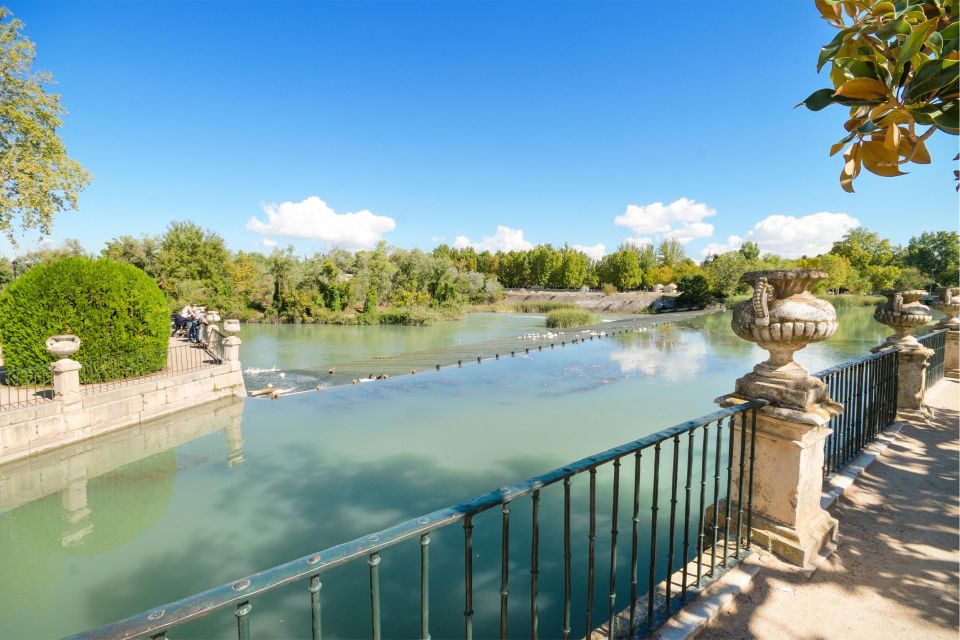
732 269 837 411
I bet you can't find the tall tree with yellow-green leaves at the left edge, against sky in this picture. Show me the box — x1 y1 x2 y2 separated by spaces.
0 7 90 244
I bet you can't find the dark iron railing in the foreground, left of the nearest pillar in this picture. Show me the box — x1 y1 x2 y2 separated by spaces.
65 401 765 640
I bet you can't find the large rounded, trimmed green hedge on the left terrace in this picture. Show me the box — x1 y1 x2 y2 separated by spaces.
0 258 170 382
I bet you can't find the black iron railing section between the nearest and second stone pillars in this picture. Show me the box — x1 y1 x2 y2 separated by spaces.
814 350 898 476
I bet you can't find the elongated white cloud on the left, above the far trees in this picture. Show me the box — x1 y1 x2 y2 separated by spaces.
247 196 397 249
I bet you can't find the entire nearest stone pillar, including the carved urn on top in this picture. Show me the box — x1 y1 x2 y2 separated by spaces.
717 269 843 567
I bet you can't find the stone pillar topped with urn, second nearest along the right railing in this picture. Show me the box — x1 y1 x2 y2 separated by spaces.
871 289 933 420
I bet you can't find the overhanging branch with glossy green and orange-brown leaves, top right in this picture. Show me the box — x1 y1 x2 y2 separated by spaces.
797 0 960 193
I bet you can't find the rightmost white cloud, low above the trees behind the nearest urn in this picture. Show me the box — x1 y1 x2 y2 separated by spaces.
703 211 860 258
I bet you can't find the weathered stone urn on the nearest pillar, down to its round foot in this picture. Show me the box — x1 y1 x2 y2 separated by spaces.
733 269 837 380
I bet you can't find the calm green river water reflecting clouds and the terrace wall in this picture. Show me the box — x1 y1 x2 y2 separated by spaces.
0 308 932 638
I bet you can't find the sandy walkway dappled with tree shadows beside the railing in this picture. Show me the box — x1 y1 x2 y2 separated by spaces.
697 380 960 640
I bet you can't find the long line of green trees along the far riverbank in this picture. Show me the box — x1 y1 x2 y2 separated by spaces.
0 222 960 324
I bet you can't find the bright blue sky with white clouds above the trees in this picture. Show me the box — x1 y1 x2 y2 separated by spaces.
7 0 958 257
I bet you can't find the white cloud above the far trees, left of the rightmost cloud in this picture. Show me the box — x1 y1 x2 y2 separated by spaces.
613 198 717 244
